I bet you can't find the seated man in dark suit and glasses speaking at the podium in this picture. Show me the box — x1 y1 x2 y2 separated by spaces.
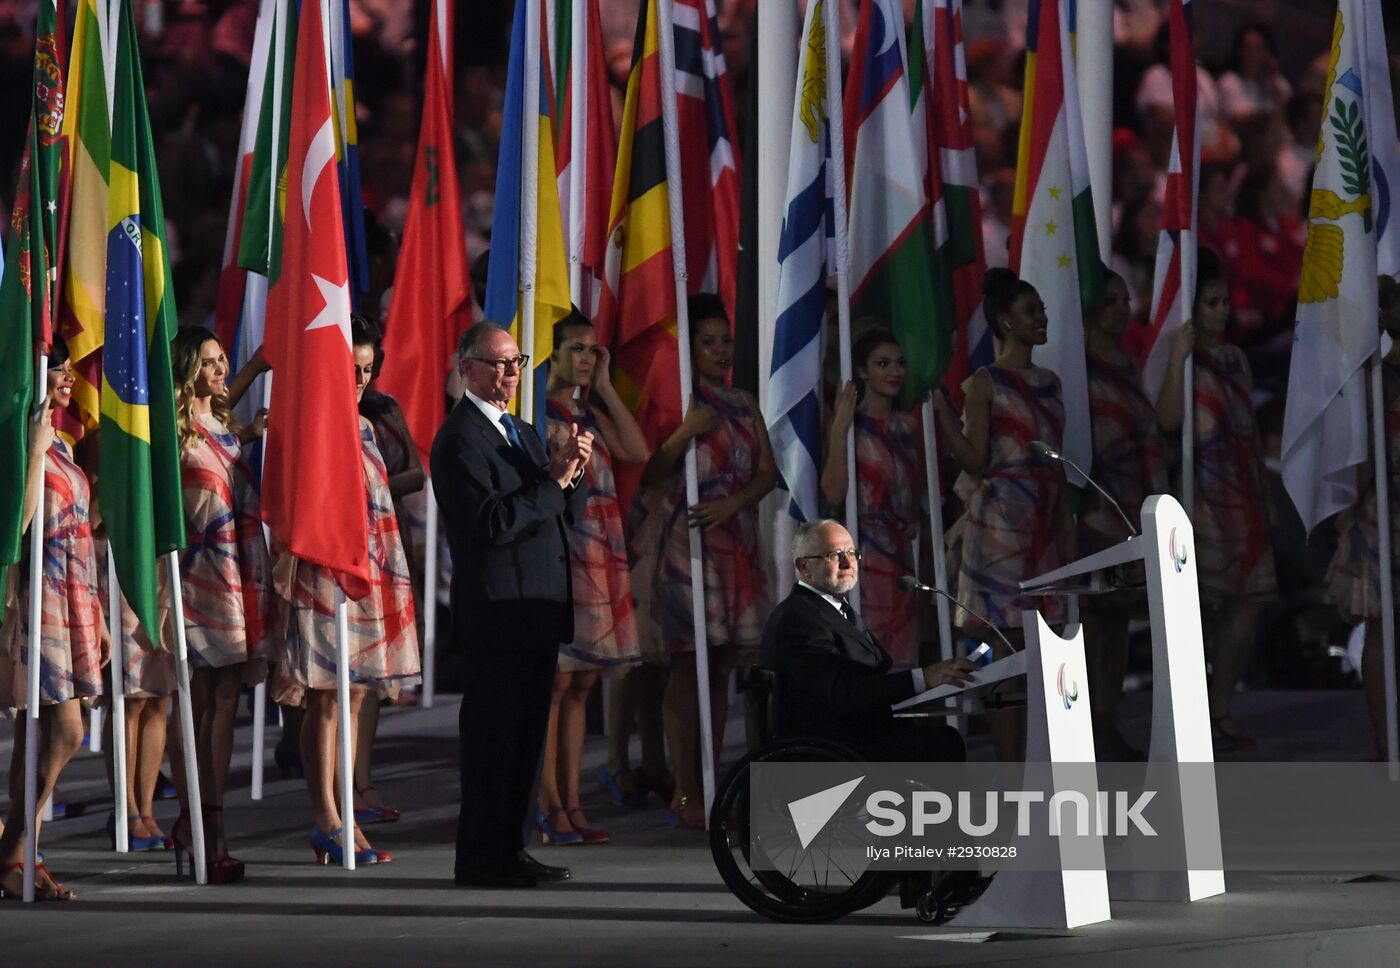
759 521 976 761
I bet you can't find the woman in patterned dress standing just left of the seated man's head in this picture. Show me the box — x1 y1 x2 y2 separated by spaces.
631 293 778 829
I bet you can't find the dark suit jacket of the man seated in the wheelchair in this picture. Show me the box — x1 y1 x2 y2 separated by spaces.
759 584 914 756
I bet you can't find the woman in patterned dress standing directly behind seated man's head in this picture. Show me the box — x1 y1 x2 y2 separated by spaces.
822 328 924 670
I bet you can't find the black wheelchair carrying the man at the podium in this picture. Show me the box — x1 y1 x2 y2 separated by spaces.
708 670 991 925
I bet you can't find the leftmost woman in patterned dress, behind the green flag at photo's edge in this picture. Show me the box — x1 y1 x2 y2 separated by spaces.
0 339 111 901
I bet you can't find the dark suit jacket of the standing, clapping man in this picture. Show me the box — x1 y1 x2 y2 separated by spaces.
430 398 588 651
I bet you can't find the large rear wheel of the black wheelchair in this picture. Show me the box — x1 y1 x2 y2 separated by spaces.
710 740 893 923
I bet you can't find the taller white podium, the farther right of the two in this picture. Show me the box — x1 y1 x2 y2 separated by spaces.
1019 495 1225 906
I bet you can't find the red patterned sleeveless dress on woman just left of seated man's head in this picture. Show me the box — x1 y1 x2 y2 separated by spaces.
631 387 769 661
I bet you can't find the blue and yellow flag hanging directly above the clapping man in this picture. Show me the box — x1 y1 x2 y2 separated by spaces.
486 0 573 434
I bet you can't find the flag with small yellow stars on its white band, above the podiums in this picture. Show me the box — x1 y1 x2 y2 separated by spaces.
1011 0 1102 471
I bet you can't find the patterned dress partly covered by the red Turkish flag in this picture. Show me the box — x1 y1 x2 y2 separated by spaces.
273 417 419 706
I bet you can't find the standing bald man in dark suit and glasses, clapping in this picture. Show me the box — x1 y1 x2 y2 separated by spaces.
431 322 592 887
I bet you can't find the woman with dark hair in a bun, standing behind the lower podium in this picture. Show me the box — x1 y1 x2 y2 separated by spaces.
934 269 1075 761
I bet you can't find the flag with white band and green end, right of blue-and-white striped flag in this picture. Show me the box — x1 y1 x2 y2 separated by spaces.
846 0 952 408
